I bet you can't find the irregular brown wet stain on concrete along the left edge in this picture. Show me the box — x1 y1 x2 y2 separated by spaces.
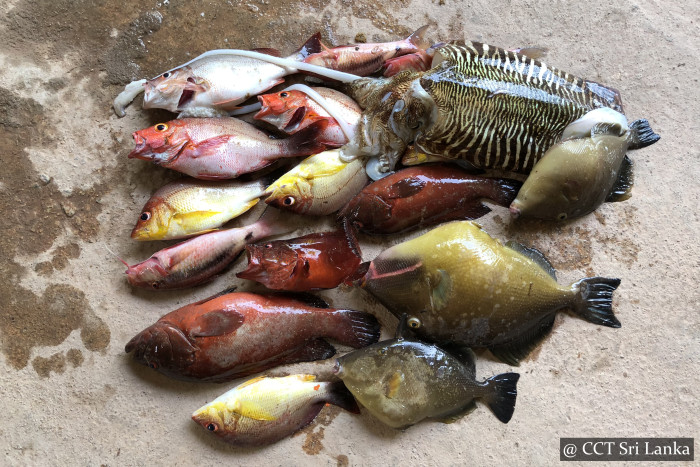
0 88 110 376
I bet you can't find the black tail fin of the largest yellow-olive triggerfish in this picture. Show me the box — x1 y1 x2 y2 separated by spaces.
573 277 621 328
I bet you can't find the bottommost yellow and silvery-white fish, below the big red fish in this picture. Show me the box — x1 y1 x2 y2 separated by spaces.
192 375 360 446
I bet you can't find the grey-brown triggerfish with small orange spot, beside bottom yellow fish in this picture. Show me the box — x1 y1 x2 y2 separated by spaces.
335 320 520 428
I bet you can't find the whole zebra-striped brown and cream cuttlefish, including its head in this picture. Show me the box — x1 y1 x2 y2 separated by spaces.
343 42 622 173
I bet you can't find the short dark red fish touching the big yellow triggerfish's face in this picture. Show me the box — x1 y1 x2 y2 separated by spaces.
236 229 362 292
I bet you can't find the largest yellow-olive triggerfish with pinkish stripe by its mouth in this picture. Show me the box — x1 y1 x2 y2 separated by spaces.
362 221 620 365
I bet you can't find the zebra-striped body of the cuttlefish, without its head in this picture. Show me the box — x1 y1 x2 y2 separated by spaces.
416 42 622 173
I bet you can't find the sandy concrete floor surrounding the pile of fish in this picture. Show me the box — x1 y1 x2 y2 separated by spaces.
0 0 700 466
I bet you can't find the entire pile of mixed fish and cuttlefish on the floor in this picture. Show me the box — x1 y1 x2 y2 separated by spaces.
114 27 659 446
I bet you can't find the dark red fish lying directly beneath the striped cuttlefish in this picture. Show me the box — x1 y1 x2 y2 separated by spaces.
338 165 522 234
